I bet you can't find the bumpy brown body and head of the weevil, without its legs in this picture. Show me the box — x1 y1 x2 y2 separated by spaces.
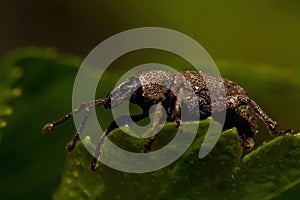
105 69 257 142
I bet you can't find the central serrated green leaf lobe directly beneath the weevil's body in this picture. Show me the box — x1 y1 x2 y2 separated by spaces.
54 120 241 199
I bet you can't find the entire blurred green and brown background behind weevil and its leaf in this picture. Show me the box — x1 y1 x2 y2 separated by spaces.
0 0 300 199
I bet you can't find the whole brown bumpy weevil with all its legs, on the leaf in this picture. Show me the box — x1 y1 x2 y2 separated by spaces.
43 69 292 170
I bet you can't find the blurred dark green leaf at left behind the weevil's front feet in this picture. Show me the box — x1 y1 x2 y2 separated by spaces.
0 47 80 199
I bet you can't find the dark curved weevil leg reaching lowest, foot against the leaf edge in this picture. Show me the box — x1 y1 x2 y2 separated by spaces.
91 112 149 170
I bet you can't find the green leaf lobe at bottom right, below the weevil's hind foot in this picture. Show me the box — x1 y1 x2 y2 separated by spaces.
234 134 300 199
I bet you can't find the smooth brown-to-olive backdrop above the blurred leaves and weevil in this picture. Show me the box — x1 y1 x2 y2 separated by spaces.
0 0 300 67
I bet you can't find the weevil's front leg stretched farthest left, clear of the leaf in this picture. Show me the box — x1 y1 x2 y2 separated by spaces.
43 98 108 133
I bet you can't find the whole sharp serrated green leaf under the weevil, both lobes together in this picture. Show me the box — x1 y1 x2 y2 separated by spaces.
54 120 300 199
